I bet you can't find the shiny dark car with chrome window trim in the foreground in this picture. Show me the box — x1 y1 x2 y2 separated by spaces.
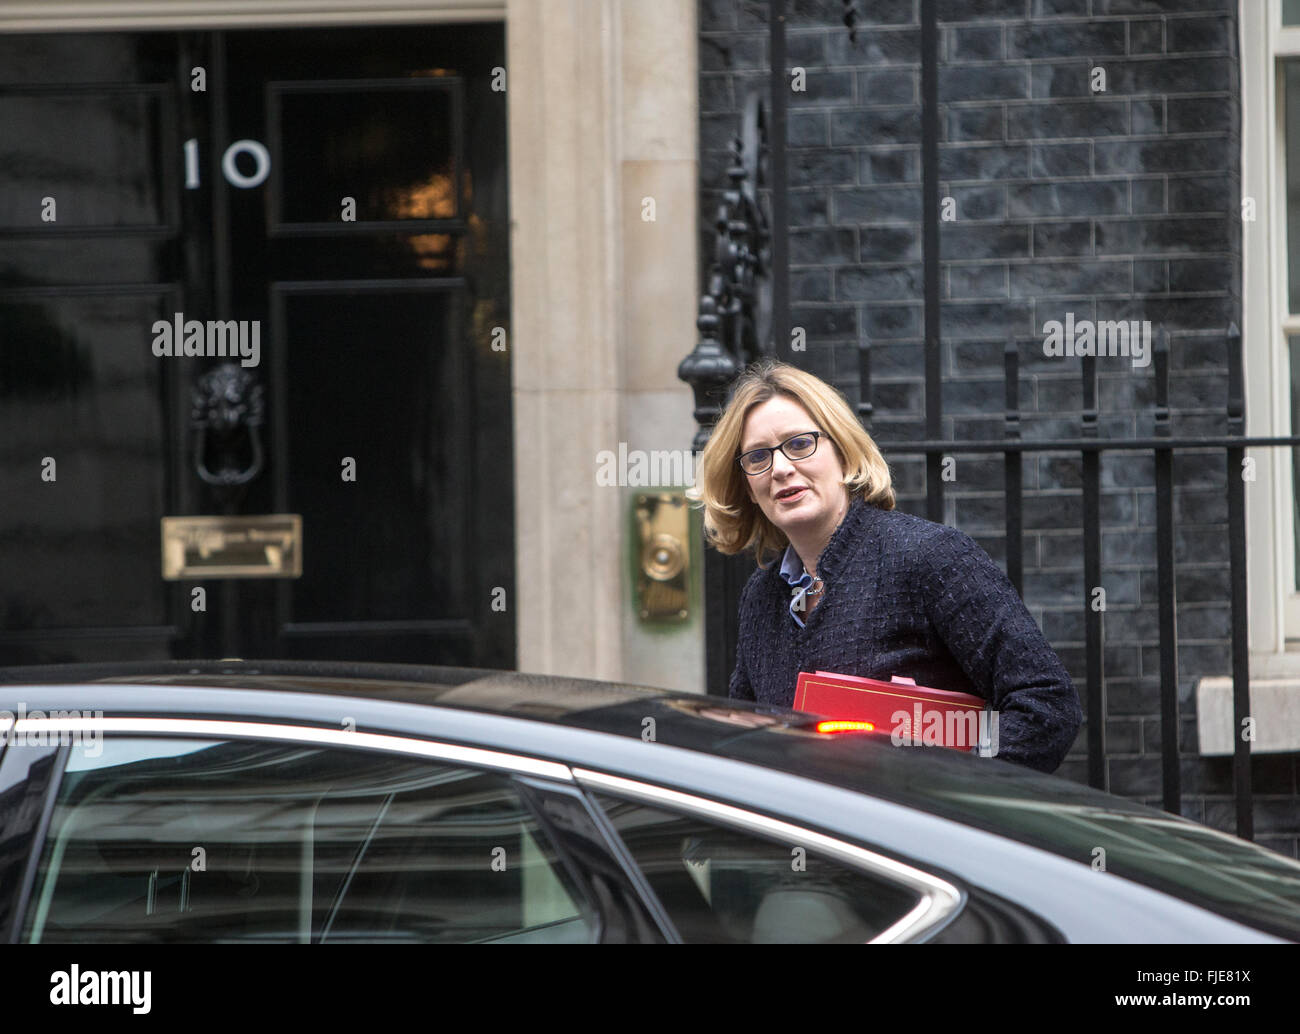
0 661 1300 943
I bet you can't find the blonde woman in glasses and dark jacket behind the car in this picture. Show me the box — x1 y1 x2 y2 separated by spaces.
692 360 1082 771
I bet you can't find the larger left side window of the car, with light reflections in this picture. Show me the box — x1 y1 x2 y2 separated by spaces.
23 737 597 943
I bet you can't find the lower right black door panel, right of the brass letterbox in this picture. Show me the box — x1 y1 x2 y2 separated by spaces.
276 280 473 636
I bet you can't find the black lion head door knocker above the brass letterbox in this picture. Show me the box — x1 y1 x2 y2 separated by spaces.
190 363 265 501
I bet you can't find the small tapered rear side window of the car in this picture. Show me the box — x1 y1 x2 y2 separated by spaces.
595 793 920 944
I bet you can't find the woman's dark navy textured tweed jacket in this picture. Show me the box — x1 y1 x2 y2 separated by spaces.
729 497 1083 771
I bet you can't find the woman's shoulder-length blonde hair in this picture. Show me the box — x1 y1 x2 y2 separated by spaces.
686 359 894 567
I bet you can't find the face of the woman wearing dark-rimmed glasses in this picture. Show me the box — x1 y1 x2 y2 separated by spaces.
740 395 849 537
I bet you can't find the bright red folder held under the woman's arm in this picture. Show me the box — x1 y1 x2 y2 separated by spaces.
794 671 985 750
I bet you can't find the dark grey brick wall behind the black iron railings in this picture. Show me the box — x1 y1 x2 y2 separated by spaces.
699 0 1300 856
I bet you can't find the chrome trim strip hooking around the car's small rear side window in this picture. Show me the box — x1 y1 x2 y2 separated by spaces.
573 769 962 944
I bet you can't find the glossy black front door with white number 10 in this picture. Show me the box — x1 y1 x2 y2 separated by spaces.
0 25 515 667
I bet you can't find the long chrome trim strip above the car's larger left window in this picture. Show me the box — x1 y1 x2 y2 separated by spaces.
8 718 573 783
